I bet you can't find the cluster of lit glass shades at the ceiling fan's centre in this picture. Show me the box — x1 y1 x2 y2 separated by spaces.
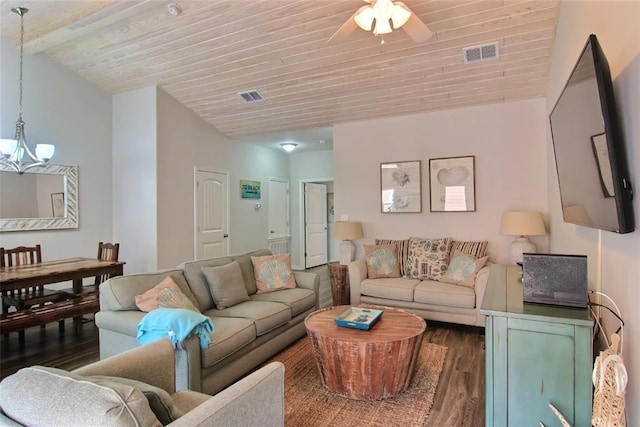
354 0 411 43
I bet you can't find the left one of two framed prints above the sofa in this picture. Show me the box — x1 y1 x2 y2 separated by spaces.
380 160 422 213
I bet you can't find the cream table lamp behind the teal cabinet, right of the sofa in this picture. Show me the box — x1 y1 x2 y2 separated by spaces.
500 211 547 264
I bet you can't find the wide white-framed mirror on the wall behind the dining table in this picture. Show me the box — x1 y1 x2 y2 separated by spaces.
0 164 78 231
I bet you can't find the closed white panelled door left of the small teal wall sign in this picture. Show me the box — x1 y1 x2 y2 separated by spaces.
195 170 229 259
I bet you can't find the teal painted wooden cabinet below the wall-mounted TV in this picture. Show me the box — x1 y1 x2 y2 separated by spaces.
480 265 593 427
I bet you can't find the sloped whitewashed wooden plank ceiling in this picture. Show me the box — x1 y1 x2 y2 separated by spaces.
0 0 559 138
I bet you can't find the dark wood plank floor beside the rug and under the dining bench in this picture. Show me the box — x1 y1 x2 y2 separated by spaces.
0 320 485 427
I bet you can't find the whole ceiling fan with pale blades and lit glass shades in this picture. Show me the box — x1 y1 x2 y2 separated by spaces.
327 0 433 44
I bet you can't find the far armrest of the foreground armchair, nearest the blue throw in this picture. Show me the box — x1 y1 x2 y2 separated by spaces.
73 339 175 393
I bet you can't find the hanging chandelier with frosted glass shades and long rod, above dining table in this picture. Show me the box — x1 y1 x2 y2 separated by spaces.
0 7 55 175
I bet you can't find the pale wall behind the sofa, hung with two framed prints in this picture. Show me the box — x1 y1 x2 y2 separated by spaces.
333 99 548 263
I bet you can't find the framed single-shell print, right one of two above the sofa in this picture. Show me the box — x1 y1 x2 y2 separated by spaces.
429 156 476 212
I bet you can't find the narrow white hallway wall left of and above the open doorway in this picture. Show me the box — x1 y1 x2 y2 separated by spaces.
289 151 333 269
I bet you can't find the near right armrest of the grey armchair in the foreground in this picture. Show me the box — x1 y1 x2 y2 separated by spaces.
169 362 284 427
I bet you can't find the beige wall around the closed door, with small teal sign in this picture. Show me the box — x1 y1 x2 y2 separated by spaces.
157 89 289 268
